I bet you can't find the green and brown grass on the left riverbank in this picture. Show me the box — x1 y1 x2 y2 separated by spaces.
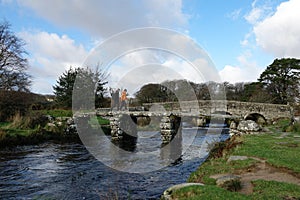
0 110 78 147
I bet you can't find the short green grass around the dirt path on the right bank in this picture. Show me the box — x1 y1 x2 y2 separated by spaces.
172 120 300 200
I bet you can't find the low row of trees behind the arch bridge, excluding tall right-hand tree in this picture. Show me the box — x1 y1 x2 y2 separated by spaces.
135 80 275 103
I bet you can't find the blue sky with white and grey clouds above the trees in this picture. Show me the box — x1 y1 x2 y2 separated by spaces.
0 0 300 94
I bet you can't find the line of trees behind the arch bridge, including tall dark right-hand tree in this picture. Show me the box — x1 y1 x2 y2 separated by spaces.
135 58 300 104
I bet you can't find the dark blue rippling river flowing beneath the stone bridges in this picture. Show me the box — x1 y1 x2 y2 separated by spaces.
0 128 228 199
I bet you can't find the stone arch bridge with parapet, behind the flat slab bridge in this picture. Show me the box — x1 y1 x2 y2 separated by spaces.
143 100 293 122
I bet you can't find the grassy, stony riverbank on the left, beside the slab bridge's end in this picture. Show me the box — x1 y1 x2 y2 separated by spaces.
0 110 110 148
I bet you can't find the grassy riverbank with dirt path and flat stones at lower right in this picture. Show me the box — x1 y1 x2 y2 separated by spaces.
169 119 300 199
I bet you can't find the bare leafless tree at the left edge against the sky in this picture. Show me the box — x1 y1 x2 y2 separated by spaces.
0 21 31 91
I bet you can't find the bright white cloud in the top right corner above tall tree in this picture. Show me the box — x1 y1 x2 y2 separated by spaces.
254 0 300 58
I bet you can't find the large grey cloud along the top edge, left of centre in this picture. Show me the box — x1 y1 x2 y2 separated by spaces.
19 0 188 38
